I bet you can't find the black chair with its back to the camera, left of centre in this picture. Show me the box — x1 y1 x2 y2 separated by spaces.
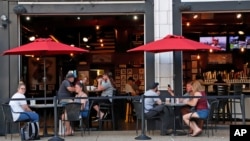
61 102 83 137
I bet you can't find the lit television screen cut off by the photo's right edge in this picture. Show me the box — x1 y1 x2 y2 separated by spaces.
228 36 250 50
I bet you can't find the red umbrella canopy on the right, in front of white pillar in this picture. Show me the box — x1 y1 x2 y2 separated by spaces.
127 35 220 53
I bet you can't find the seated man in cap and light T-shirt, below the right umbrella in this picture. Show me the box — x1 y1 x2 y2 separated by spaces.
144 82 173 136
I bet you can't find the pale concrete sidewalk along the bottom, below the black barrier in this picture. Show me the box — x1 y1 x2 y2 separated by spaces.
0 126 229 141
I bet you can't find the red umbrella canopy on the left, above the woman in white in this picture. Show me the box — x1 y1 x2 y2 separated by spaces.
3 38 89 56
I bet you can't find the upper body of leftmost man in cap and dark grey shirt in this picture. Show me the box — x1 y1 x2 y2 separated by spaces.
58 73 75 104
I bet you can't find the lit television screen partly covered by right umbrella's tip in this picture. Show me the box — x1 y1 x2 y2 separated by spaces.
200 36 227 51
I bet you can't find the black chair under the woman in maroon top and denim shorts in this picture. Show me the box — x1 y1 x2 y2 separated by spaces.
190 100 219 137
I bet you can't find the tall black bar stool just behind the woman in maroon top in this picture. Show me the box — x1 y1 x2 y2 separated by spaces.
216 84 232 123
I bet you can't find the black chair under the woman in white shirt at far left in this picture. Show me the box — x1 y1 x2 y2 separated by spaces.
2 104 28 140
